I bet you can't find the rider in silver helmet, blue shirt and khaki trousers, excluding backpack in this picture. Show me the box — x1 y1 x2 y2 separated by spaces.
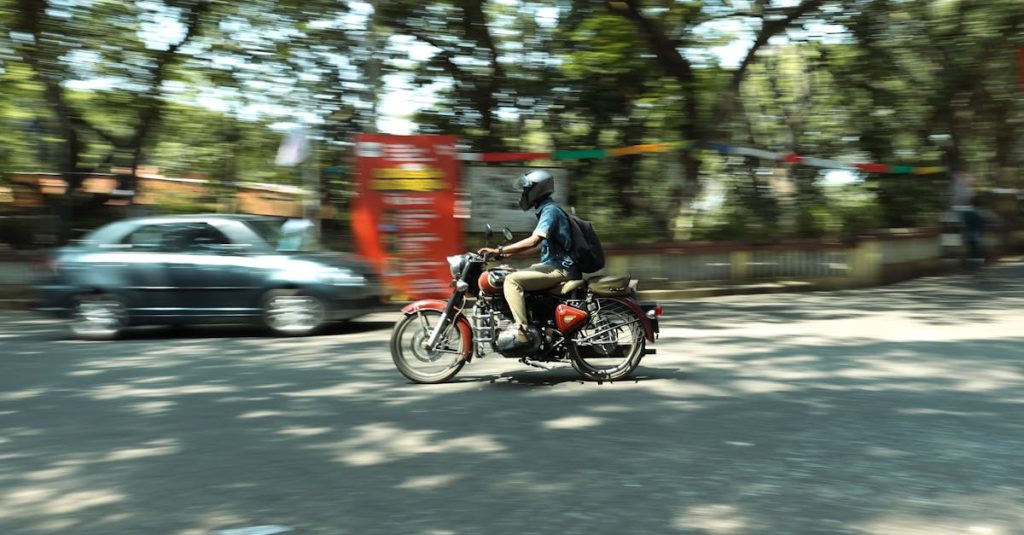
479 170 581 344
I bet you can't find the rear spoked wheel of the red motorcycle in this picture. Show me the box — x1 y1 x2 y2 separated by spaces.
570 299 645 380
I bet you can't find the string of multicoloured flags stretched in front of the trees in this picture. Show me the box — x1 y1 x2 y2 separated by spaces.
459 141 947 175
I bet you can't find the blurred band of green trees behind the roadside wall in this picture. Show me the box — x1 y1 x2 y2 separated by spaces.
0 0 1024 243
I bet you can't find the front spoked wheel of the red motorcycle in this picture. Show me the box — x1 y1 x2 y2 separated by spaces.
391 311 467 383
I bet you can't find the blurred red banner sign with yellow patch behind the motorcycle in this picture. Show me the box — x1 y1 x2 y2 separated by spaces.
352 134 465 300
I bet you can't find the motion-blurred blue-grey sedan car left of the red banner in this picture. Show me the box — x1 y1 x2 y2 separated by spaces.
35 214 384 338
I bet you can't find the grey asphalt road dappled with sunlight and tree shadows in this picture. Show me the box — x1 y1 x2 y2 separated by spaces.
0 264 1024 535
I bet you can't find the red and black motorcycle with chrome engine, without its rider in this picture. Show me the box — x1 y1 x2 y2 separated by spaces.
391 227 662 383
